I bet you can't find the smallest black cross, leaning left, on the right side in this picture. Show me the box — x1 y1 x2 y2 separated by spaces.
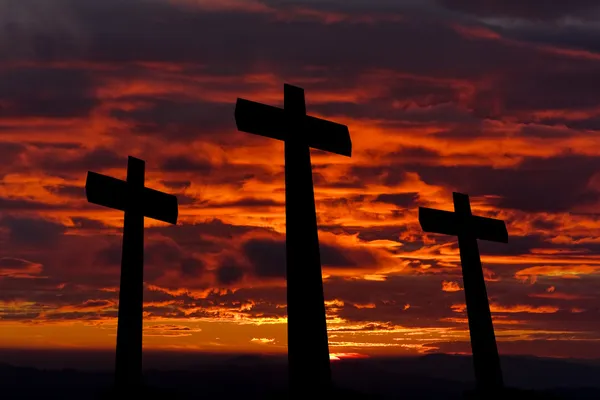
419 193 508 393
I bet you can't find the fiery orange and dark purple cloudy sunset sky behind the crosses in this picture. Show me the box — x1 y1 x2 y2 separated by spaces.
0 0 600 359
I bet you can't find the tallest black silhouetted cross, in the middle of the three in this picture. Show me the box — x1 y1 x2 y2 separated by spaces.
235 84 352 394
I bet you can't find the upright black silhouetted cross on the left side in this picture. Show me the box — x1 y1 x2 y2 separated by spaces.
85 157 178 390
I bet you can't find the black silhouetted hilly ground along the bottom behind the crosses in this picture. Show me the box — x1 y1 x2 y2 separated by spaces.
0 351 600 400
